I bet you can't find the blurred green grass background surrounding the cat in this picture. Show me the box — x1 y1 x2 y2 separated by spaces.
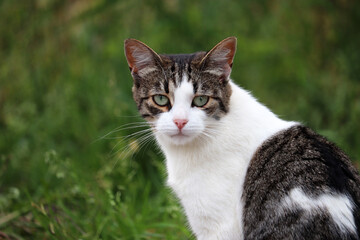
0 0 360 239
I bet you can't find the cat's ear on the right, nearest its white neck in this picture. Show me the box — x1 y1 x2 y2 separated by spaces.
200 37 236 81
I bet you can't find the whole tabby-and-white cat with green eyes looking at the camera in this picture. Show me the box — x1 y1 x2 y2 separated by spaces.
125 37 360 240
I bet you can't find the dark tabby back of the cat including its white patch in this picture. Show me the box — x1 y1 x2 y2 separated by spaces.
242 125 360 239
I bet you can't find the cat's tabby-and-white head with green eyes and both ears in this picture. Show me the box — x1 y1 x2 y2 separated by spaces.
125 37 236 145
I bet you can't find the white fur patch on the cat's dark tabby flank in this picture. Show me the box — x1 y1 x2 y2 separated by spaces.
282 188 356 233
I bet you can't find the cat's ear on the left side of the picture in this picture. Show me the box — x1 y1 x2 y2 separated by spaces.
124 39 162 75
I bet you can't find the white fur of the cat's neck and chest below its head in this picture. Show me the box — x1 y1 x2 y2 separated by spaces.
156 83 295 240
